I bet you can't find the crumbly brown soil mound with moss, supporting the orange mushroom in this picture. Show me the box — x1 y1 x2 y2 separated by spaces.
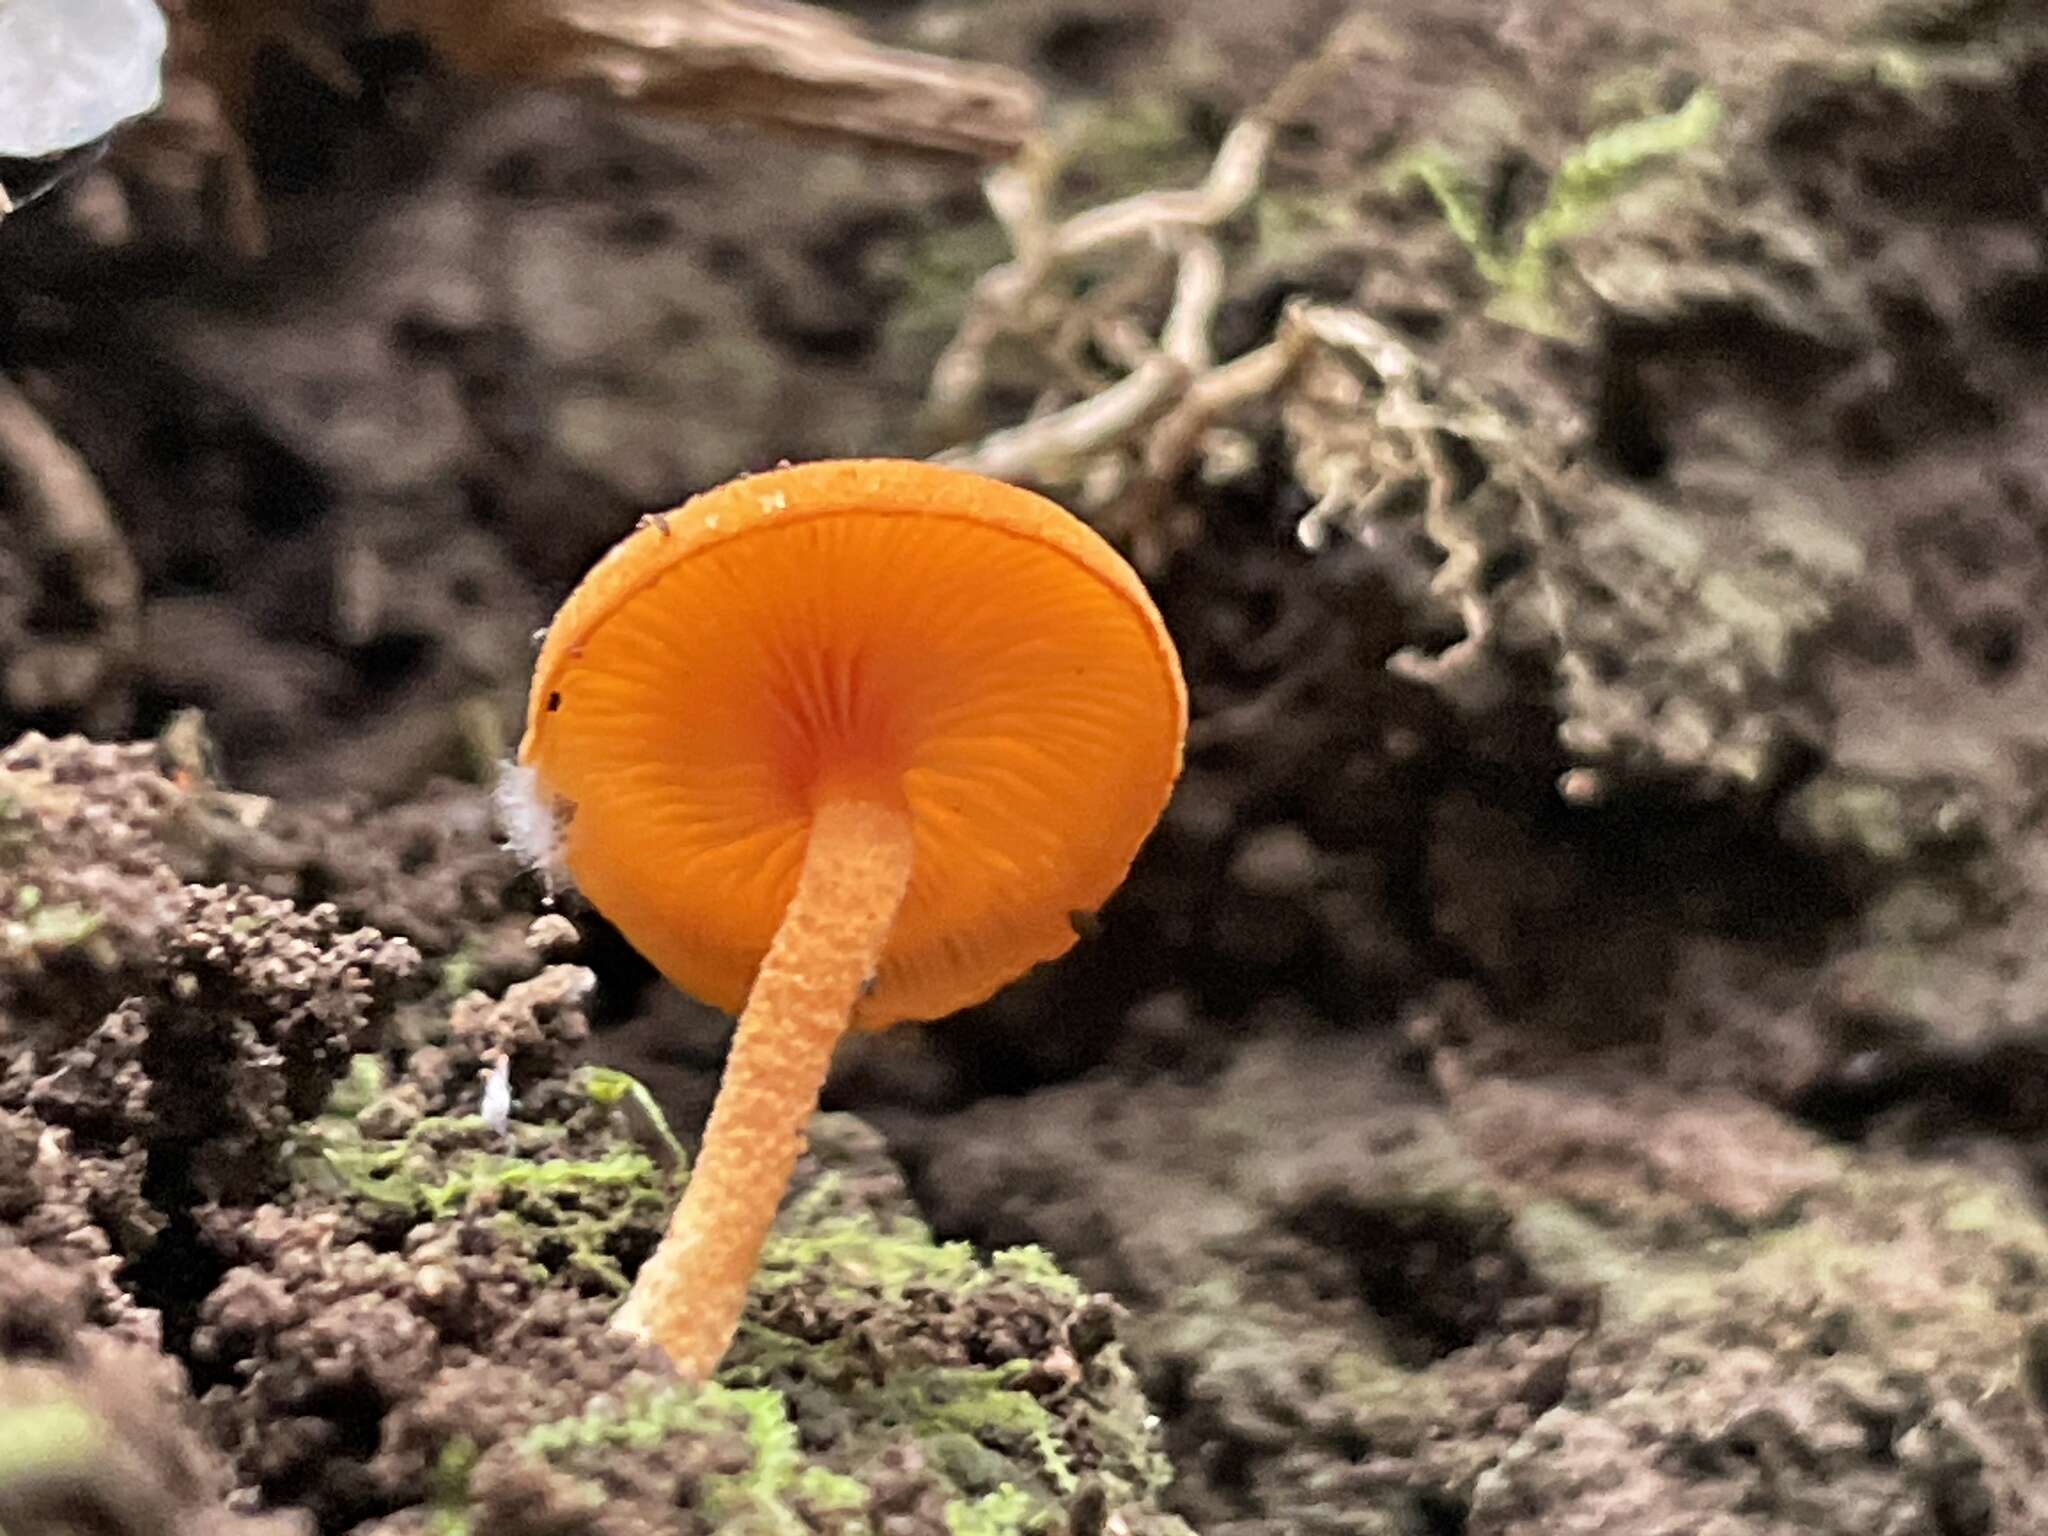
0 741 1182 1536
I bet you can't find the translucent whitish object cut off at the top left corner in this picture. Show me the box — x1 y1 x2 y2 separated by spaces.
0 0 168 160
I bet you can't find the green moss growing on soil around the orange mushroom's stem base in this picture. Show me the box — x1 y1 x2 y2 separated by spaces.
289 1057 1169 1536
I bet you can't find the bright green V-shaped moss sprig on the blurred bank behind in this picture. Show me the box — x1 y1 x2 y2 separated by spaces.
1393 88 1720 334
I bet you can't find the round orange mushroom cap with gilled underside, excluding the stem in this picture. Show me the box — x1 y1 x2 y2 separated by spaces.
520 459 1188 1028
